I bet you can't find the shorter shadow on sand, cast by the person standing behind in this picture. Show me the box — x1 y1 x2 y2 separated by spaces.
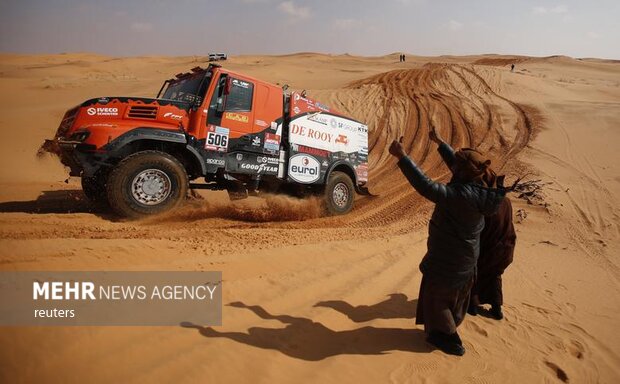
314 293 418 323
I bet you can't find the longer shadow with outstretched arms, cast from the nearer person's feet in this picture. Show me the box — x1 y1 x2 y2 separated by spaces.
181 302 432 361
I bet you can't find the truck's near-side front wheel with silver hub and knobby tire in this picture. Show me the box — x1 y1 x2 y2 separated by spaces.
107 151 189 219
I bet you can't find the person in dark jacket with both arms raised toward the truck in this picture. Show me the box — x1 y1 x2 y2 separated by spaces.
389 128 505 356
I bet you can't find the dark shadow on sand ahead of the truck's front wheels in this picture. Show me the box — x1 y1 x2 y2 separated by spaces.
0 189 115 220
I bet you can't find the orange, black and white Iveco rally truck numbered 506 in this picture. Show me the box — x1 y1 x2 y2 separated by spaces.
44 64 368 218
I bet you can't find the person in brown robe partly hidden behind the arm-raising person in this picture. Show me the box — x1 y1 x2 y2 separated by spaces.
467 197 517 320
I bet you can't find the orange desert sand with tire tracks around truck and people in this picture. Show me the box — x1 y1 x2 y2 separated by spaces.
0 53 620 383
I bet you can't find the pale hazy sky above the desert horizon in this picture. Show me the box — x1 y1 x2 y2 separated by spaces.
0 0 620 59
